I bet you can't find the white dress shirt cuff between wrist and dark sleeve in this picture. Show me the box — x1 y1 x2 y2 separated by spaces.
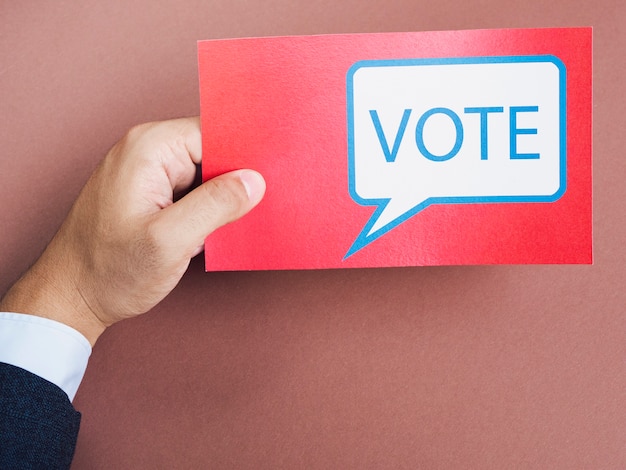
0 312 91 401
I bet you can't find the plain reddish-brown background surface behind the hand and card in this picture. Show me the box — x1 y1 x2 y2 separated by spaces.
0 0 626 469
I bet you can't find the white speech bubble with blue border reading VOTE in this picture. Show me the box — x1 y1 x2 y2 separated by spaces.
344 55 566 259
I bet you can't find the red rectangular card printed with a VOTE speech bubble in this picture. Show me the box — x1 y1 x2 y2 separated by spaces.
198 28 592 271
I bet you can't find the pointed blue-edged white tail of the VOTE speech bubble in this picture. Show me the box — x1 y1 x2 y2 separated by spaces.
343 199 429 261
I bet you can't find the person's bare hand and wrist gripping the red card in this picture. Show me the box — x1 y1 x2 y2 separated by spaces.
0 118 265 345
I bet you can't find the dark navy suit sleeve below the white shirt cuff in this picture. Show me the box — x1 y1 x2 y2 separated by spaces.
0 363 80 469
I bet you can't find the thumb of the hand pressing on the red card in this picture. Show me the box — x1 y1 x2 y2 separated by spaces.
159 170 265 257
